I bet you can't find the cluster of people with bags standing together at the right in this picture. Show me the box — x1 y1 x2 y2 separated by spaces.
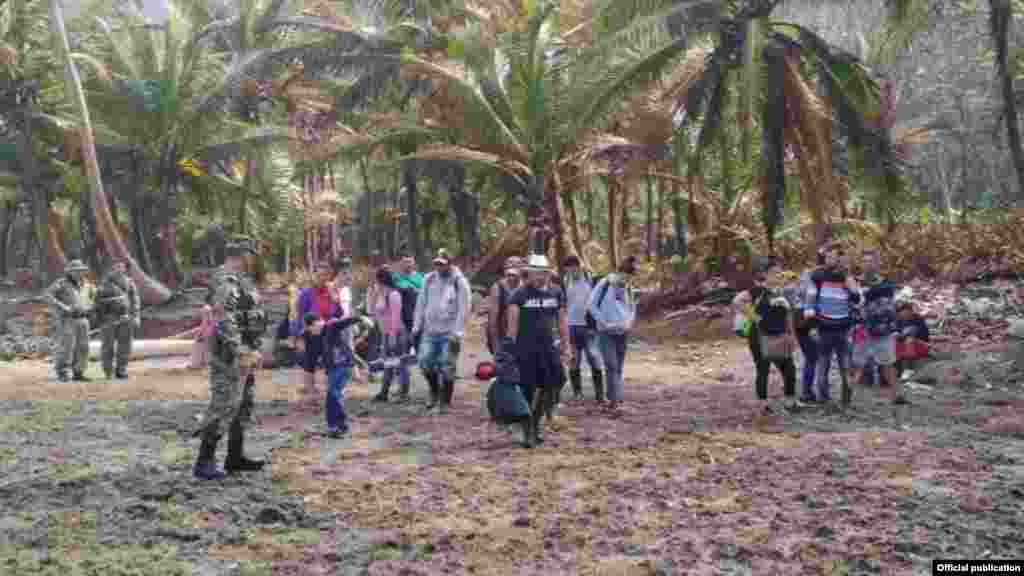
733 242 929 412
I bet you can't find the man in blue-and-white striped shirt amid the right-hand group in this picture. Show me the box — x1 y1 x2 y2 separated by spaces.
804 243 860 406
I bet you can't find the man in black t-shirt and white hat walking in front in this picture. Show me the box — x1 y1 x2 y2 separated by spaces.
503 254 571 447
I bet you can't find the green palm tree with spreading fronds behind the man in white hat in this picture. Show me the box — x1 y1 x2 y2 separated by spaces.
288 1 696 270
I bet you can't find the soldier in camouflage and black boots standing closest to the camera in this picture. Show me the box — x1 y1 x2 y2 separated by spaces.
193 238 265 480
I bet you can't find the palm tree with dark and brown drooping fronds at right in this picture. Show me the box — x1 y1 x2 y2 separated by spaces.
598 0 903 251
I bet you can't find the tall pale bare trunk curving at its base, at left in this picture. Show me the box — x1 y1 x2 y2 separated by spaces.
50 0 173 304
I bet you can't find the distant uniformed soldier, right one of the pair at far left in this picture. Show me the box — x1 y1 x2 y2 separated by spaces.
96 258 140 379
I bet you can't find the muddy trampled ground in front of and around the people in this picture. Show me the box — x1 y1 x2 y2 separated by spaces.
0 323 1024 576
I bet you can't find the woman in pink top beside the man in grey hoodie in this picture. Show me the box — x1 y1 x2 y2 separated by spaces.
367 266 410 402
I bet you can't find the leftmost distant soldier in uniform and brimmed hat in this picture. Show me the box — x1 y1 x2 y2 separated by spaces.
45 260 91 382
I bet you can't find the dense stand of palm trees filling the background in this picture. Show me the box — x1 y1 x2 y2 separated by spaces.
0 0 1024 303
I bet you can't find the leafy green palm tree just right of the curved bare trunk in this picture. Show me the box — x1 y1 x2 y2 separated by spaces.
69 0 294 285
